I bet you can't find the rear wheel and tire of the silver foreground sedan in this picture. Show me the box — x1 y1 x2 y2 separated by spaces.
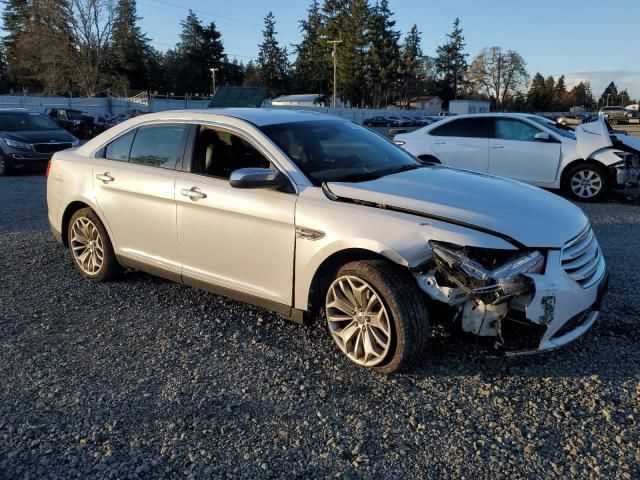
67 208 121 282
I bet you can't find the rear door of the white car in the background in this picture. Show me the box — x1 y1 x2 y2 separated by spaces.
428 117 489 172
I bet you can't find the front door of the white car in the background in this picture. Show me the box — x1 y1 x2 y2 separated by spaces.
489 117 561 185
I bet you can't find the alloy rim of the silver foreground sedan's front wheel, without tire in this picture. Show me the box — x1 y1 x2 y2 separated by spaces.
325 275 392 367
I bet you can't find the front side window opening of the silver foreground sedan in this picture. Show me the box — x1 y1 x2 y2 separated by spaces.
192 126 271 179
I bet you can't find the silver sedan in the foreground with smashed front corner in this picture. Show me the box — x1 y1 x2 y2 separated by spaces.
47 109 607 372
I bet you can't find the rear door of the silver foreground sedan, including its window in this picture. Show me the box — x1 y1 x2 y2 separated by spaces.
93 123 187 278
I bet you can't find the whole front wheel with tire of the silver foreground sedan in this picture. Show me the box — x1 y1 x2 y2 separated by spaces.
324 260 429 373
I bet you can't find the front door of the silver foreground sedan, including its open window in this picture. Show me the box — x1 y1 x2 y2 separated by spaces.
175 126 297 306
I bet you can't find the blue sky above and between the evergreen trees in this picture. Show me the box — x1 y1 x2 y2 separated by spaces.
138 0 640 97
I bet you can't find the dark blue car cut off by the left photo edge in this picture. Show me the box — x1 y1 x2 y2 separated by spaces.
0 108 80 176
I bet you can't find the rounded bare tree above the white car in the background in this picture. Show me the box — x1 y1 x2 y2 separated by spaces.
467 47 529 109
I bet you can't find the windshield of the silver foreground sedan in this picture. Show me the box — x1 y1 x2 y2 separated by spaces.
261 120 422 186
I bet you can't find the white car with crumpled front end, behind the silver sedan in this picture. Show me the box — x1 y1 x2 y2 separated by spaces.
394 113 640 201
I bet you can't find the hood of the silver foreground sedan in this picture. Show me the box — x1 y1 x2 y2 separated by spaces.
327 165 588 248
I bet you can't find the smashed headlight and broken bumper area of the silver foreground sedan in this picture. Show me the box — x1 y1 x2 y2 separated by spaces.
413 240 599 355
